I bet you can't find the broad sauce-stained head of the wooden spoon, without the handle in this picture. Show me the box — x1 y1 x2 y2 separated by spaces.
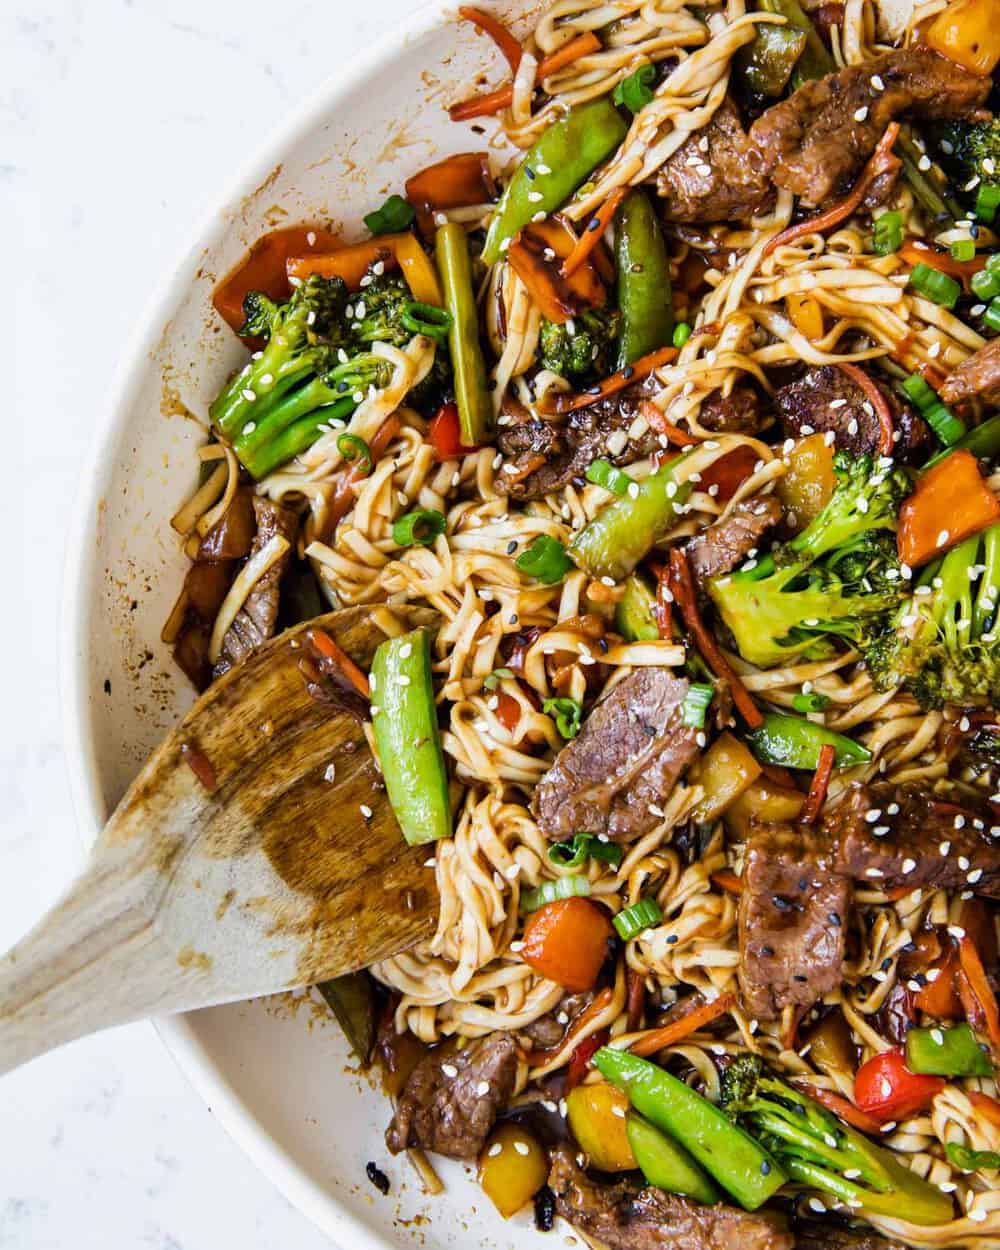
102 608 438 1001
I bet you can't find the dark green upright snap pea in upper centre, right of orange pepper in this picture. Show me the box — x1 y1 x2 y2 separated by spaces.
615 190 674 369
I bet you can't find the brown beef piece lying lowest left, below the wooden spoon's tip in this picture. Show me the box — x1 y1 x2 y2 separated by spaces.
385 1033 518 1159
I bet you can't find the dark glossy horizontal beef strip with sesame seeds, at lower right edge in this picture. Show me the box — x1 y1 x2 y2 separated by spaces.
824 783 1000 899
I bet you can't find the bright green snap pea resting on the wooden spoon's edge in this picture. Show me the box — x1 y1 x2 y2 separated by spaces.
369 629 451 845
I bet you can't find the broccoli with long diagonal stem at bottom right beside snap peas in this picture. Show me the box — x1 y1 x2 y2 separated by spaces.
721 1054 954 1225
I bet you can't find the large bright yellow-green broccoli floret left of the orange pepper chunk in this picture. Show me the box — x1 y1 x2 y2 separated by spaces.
708 453 909 668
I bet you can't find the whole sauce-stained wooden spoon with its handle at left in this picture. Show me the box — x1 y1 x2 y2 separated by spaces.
0 608 438 1073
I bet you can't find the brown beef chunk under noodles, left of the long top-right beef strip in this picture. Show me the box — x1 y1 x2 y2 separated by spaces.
656 96 774 221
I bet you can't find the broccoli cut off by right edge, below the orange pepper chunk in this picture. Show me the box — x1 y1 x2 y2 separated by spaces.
865 525 1000 708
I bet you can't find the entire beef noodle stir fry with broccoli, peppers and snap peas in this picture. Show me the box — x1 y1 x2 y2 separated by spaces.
164 0 1000 1250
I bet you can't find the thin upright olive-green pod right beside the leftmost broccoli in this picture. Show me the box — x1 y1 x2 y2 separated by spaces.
435 221 494 448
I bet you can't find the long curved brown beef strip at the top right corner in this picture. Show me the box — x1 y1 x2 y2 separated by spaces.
750 48 990 208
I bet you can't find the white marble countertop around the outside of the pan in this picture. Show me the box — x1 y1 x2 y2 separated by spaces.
0 0 414 1250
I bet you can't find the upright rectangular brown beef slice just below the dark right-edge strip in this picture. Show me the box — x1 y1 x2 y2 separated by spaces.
739 825 850 1020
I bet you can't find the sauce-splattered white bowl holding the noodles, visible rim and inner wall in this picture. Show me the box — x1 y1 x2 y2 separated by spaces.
63 0 538 1250
